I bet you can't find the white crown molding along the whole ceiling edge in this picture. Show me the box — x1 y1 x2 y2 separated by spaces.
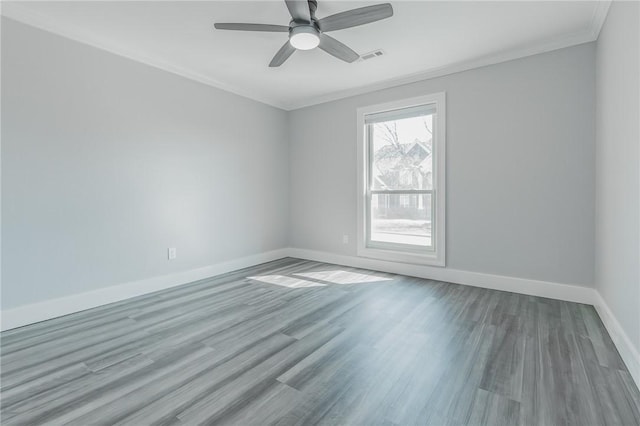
2 0 612 111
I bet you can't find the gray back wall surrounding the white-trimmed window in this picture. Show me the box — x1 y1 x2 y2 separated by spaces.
290 43 595 286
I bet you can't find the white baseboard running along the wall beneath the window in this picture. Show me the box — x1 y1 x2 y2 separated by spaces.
289 248 596 305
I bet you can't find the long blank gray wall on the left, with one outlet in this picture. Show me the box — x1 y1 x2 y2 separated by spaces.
2 19 289 309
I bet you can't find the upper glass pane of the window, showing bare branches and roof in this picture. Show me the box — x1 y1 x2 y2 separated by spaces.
367 114 433 190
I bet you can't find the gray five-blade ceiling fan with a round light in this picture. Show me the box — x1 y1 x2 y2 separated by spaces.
214 0 393 67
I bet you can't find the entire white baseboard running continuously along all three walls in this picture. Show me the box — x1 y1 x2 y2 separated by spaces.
0 248 640 392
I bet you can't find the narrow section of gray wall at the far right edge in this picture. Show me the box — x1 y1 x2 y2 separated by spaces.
596 2 640 351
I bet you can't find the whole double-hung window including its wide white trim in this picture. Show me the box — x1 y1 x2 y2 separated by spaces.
358 93 445 266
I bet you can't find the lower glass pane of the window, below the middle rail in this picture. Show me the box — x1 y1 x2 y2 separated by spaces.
370 194 433 248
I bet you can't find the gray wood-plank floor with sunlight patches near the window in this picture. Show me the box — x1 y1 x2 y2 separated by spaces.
0 259 640 425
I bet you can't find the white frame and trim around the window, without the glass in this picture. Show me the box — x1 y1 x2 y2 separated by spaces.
357 92 446 266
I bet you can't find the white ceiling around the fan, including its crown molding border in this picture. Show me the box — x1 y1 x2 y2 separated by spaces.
2 0 609 109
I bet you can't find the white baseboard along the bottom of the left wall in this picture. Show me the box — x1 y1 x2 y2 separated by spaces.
0 249 288 331
